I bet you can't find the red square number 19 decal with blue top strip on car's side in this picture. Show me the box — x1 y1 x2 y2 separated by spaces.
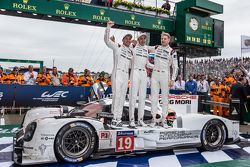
115 131 135 152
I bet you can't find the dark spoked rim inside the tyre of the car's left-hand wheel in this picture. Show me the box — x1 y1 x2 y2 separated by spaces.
62 128 90 158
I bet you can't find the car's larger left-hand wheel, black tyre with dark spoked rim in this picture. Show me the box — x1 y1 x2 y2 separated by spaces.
54 122 97 163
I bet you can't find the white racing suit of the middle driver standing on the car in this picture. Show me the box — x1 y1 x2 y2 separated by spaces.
129 44 154 121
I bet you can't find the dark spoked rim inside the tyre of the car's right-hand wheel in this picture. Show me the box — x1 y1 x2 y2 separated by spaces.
205 124 222 146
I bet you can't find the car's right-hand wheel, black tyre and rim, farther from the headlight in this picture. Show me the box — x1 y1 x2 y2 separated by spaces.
201 119 226 151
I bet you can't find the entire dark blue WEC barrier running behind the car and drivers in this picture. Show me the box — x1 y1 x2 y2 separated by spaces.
0 84 190 107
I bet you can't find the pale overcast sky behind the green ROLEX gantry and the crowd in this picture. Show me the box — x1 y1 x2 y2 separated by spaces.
0 0 250 72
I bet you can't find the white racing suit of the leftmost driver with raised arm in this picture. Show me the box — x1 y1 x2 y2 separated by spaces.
104 26 132 121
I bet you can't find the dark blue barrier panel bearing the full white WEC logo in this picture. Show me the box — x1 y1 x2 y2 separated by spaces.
15 85 90 107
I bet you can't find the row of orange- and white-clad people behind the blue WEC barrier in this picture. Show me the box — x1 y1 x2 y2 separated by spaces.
0 65 111 86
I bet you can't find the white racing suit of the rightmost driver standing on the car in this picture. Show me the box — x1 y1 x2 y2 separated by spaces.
151 46 178 122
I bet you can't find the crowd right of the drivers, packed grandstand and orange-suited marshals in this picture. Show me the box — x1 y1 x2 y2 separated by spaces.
179 58 250 124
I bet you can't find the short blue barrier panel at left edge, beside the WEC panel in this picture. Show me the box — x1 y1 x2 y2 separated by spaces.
0 84 15 107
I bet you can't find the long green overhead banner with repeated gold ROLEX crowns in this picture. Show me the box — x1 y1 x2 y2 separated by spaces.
0 0 175 33
